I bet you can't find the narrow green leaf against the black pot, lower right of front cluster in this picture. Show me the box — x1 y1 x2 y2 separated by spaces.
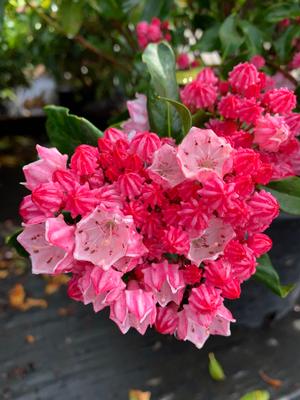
254 254 295 298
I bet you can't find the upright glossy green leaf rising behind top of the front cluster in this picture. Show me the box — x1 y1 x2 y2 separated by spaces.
142 42 182 140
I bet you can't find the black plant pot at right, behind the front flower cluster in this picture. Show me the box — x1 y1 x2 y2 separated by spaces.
227 214 300 328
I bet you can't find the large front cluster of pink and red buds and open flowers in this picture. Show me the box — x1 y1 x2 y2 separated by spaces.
18 117 283 348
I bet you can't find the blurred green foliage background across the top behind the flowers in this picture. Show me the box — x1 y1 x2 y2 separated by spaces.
0 0 300 118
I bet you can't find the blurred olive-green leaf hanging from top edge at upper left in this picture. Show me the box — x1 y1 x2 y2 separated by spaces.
57 0 84 38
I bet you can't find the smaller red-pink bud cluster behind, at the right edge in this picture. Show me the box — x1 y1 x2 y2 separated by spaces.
181 62 300 179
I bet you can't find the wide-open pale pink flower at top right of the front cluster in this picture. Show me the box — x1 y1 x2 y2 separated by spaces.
177 128 232 181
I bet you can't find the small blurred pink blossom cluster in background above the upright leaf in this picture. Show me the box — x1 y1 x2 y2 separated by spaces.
136 17 171 49
